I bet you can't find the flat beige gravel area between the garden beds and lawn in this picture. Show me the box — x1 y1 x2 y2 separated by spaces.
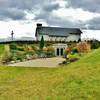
8 57 65 67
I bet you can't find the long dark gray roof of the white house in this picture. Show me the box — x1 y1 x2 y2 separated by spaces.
36 26 82 36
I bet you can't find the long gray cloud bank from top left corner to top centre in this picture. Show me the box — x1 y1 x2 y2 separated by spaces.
0 0 59 20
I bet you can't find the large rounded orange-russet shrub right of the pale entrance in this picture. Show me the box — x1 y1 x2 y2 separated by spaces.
77 42 91 53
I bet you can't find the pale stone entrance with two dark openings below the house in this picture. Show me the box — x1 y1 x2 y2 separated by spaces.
53 43 68 56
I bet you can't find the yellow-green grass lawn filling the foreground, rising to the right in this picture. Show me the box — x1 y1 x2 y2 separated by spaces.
0 49 100 100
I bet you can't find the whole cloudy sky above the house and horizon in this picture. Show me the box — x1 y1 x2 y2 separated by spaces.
0 0 100 40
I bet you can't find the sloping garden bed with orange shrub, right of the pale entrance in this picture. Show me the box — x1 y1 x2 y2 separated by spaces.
59 42 91 65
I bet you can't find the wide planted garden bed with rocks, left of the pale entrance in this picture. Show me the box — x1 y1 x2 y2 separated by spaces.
2 43 54 64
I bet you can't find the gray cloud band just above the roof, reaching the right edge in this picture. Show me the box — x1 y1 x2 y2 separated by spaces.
35 10 100 30
